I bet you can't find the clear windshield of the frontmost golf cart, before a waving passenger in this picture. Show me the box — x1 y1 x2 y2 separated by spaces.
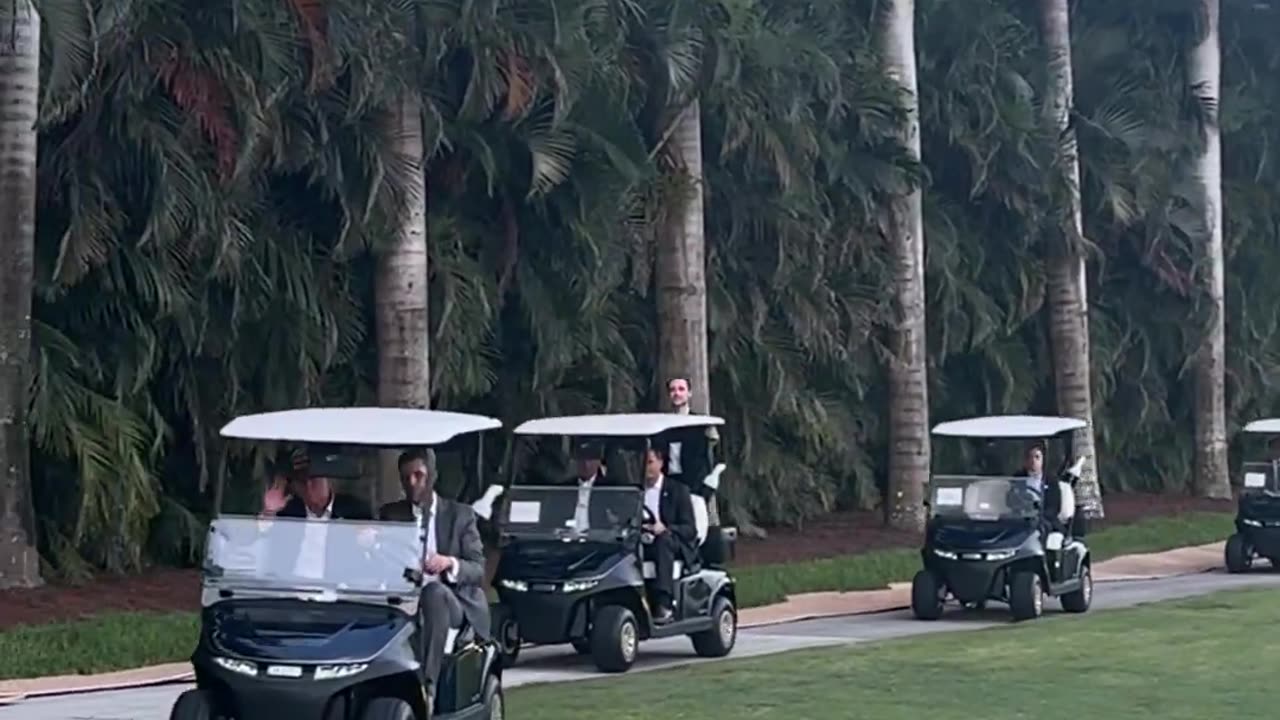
205 515 422 594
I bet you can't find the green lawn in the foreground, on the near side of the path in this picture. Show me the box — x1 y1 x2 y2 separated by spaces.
507 591 1280 720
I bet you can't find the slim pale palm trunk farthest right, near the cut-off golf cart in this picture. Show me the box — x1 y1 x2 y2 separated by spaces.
1187 0 1231 498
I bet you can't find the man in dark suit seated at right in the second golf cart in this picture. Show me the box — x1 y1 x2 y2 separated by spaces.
644 447 698 623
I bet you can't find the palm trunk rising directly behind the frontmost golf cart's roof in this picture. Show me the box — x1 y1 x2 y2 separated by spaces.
374 94 431 503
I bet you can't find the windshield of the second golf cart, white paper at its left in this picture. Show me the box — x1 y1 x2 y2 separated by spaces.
502 484 643 538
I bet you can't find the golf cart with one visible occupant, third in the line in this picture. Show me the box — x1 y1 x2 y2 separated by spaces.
911 415 1093 620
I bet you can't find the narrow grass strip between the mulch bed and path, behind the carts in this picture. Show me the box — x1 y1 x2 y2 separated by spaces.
0 512 1231 680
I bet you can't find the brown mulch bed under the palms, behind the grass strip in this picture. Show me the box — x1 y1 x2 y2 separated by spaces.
0 486 1235 630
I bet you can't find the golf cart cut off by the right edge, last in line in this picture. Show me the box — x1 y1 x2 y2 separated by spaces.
1224 418 1280 573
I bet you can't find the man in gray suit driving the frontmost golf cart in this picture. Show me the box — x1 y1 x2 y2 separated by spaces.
378 448 489 707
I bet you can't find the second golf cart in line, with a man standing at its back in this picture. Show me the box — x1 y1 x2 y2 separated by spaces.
483 413 737 673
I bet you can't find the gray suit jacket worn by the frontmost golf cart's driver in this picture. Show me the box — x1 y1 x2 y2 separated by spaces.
378 495 489 637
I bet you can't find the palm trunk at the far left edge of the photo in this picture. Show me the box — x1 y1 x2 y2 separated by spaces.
0 0 41 588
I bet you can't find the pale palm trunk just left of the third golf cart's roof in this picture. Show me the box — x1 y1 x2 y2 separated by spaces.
877 0 929 530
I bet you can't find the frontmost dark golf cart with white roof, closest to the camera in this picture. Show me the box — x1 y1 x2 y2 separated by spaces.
170 407 504 720
